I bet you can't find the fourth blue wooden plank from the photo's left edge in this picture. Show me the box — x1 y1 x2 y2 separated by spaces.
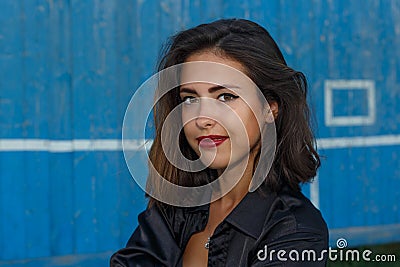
71 0 99 253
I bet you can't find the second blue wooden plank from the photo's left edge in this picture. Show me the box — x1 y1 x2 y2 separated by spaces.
23 1 51 258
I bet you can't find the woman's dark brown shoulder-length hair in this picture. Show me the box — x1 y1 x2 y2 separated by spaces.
149 19 320 205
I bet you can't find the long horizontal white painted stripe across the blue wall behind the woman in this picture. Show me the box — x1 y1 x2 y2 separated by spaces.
0 135 400 153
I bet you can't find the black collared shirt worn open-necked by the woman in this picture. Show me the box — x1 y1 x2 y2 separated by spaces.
110 186 328 267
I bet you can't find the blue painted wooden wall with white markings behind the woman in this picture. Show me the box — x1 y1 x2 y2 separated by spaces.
0 0 400 266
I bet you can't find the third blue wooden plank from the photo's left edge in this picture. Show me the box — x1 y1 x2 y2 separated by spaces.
47 1 75 255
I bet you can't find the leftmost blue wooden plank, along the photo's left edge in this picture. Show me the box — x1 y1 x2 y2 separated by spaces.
0 1 26 259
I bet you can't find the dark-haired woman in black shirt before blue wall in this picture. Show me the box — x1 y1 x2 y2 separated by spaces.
111 19 328 266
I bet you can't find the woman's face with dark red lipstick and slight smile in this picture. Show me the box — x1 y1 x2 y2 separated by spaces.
179 52 265 169
